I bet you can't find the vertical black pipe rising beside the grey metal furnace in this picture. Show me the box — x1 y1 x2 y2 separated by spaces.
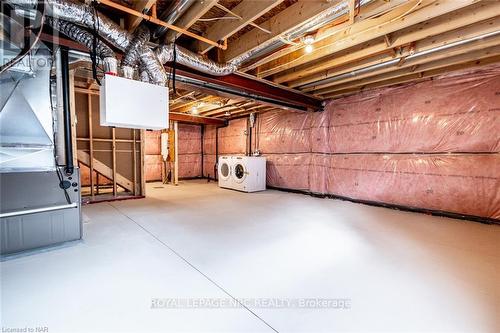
61 47 75 176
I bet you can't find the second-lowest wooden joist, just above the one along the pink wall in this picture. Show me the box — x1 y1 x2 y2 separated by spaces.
322 45 500 97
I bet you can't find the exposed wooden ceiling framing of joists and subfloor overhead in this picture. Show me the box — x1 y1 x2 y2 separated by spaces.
51 0 500 123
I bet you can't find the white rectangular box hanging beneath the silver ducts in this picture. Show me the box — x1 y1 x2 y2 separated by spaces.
100 74 168 130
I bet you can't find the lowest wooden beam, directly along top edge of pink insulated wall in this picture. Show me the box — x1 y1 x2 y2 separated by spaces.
326 56 500 98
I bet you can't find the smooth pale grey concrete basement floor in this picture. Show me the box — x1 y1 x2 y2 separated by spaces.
1 181 500 332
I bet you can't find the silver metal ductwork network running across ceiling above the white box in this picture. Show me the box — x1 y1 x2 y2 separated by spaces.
7 0 358 85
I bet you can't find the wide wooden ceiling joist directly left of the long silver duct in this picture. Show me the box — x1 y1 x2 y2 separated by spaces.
224 0 341 61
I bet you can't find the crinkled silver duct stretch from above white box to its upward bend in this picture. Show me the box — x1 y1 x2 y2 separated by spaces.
155 44 238 76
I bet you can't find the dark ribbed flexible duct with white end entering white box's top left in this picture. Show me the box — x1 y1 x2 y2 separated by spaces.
45 17 117 74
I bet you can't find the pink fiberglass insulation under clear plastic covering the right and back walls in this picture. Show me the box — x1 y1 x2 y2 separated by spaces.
212 66 500 220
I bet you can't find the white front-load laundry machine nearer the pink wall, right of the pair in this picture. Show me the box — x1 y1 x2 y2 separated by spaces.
231 156 266 192
